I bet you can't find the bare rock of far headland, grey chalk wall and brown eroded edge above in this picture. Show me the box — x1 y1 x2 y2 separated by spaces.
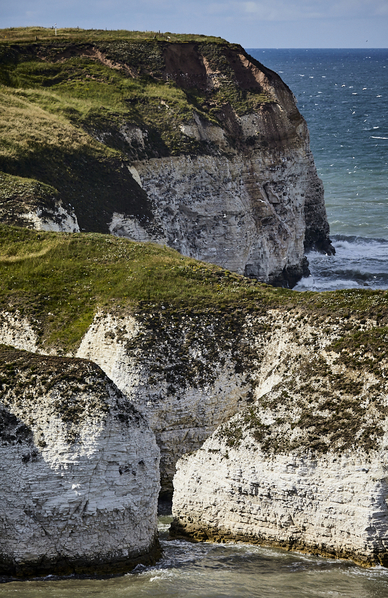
104 45 334 287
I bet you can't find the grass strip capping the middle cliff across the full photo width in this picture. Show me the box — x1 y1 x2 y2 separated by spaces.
0 225 388 350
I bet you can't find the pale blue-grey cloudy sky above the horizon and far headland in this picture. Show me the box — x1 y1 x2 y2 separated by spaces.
0 0 388 48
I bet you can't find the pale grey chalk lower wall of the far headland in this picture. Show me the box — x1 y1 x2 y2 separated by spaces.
119 150 321 287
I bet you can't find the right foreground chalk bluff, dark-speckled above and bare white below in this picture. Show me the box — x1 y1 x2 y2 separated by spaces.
172 321 388 566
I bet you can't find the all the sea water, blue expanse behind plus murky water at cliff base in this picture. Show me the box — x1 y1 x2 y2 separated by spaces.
0 49 388 598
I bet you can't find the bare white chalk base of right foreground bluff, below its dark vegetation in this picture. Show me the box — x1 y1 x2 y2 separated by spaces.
173 438 388 565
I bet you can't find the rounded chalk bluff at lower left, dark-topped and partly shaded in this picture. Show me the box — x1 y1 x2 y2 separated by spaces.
0 345 159 577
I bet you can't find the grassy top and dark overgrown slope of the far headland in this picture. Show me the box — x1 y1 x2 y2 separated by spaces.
0 27 273 232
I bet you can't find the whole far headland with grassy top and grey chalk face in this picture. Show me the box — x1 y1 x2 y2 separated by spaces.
0 31 333 287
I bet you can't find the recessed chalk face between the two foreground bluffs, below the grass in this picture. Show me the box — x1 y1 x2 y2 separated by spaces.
77 312 249 495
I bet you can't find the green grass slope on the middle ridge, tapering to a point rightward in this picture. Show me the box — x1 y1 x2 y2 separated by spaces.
0 226 283 354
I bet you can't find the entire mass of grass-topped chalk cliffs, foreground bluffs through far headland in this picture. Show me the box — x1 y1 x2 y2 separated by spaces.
0 28 388 577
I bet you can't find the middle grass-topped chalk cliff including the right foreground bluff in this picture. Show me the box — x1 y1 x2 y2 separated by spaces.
0 227 388 564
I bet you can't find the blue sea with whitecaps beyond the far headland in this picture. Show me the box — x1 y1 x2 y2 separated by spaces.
248 49 388 291
